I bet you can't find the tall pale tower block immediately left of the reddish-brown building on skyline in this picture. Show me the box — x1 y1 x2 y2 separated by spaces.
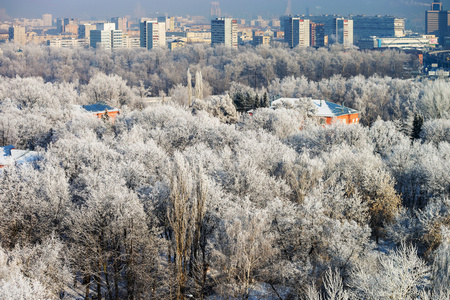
282 17 310 48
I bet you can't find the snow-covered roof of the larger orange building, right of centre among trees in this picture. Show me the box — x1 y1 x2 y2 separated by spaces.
272 98 358 118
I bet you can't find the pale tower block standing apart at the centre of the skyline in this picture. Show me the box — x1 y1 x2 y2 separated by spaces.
211 18 238 48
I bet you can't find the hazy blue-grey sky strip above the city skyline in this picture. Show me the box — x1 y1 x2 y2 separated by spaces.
0 0 442 19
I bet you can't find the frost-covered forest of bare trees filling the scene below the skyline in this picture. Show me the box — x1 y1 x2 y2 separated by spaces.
0 44 450 300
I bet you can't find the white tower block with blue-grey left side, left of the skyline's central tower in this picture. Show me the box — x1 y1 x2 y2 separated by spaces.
140 20 166 50
